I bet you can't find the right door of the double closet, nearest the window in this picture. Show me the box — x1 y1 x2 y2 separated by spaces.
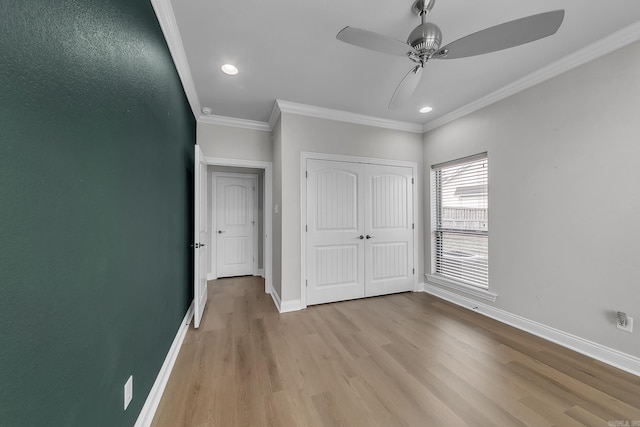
364 165 413 297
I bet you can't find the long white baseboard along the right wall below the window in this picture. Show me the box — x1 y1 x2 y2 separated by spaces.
424 284 640 376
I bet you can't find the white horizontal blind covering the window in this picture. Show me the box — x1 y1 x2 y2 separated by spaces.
433 153 489 289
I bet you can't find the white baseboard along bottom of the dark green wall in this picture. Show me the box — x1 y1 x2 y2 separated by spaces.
135 302 193 427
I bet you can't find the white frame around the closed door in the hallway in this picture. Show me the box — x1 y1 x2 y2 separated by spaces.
209 172 264 279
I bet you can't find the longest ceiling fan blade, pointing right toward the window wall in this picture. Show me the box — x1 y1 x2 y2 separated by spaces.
433 10 564 59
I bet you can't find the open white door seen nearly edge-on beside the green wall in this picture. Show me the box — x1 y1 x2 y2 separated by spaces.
193 145 207 328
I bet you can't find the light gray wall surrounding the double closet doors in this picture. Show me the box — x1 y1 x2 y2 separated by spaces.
274 113 424 301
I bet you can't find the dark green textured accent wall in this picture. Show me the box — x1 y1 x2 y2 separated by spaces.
0 0 195 426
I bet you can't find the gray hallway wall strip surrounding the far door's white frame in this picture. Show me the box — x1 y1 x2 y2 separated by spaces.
207 165 264 274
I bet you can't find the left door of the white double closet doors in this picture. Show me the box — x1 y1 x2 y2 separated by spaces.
308 160 365 305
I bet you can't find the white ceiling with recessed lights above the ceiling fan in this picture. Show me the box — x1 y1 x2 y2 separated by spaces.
165 0 640 130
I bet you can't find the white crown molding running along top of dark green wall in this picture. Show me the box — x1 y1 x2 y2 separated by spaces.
151 0 200 119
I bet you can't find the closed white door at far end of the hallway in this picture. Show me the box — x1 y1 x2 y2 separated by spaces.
215 176 257 277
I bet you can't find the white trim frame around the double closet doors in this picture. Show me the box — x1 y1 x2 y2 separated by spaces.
300 151 422 309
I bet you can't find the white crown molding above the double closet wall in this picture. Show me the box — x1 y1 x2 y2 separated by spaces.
269 99 424 133
